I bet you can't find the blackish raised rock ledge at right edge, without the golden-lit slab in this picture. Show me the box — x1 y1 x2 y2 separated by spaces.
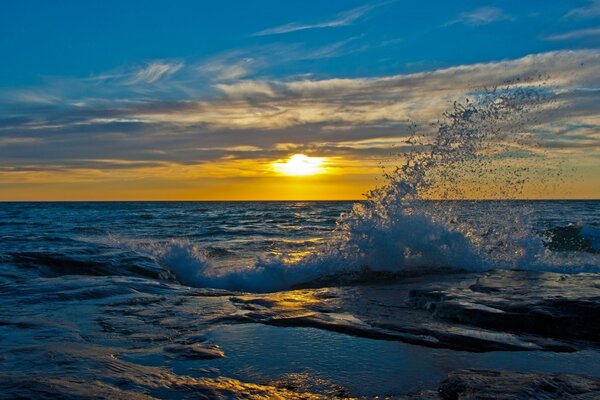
410 271 600 344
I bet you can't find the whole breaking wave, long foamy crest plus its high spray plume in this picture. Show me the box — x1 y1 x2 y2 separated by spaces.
101 80 600 292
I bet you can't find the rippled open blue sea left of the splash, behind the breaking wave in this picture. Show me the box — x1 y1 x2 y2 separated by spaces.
0 202 352 273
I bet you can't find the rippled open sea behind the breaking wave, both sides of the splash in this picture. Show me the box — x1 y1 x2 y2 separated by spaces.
0 201 600 274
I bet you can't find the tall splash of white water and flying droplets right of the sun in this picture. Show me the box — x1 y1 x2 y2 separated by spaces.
326 85 550 271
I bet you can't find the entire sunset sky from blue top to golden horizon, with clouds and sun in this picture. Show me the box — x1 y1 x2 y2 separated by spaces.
0 0 600 201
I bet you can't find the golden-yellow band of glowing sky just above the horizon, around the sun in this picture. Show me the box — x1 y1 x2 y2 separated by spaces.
0 150 600 201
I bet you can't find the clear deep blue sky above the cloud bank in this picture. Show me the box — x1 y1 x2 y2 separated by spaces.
0 0 600 87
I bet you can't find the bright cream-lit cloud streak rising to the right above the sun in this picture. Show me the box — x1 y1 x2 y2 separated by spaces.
195 52 600 129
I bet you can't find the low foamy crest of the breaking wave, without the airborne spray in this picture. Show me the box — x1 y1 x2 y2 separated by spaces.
108 227 600 293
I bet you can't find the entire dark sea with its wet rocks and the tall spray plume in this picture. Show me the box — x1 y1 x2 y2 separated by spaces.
0 85 600 399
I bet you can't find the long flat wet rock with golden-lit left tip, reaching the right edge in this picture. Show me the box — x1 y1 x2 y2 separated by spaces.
225 270 600 352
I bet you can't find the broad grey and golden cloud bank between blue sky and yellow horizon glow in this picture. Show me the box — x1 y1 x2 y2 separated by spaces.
0 50 600 180
